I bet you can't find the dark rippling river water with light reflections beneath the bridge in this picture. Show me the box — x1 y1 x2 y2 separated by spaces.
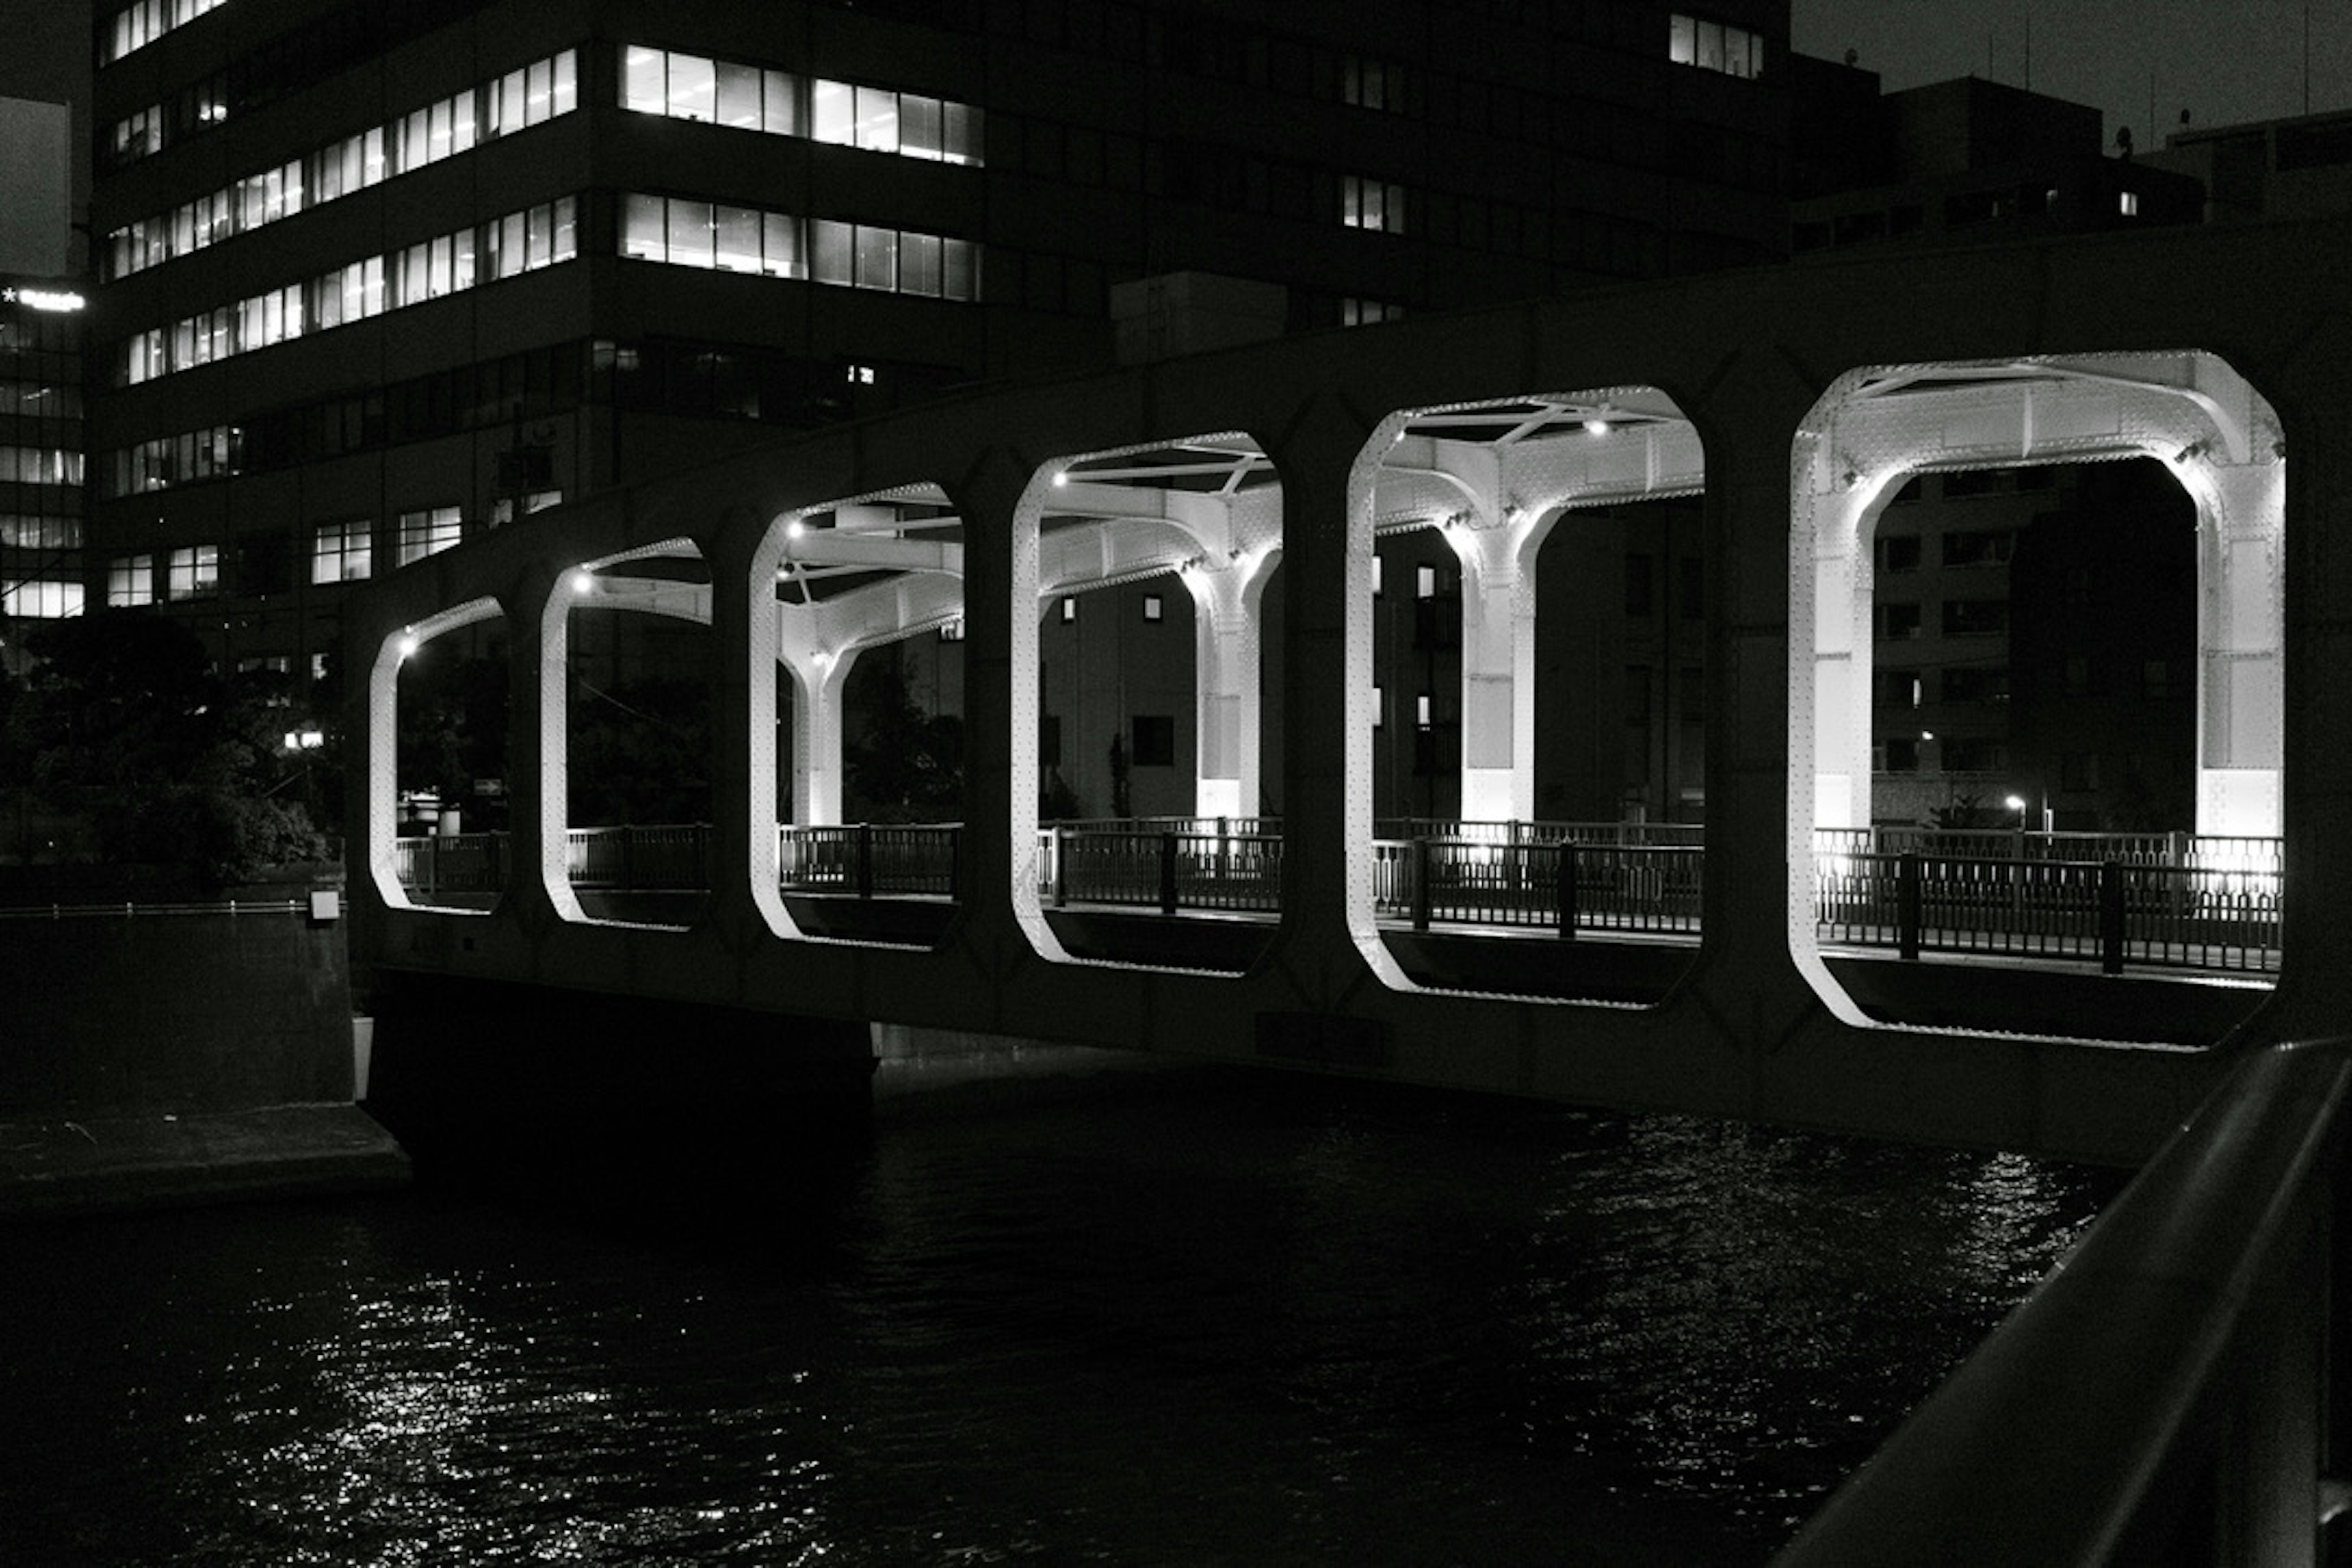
0 1074 2119 1568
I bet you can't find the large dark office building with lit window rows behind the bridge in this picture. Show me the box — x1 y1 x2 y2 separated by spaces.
85 0 1787 673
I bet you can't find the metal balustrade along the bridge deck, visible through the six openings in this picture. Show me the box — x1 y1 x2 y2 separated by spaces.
395 818 2282 973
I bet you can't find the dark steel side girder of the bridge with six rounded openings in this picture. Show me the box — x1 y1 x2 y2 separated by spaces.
345 221 2352 1166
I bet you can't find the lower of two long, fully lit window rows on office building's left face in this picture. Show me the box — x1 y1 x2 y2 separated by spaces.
120 195 579 385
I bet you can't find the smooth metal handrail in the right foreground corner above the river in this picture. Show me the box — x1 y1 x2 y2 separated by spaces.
1773 1039 2352 1568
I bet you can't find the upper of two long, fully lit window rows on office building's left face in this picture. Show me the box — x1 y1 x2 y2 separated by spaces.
108 50 579 277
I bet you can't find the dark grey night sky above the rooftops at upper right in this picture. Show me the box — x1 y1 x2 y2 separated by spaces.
1790 0 2352 148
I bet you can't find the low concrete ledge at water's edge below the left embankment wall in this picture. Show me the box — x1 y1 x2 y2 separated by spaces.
0 1105 409 1220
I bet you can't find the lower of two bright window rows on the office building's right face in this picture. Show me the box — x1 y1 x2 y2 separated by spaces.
621 193 981 298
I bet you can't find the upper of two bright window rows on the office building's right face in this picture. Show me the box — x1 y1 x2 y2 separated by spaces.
621 45 981 165
